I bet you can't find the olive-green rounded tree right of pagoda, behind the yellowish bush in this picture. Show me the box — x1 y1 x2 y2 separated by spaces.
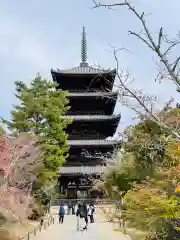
104 120 165 199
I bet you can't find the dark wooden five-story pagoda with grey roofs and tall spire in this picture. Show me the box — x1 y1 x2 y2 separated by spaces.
51 28 120 198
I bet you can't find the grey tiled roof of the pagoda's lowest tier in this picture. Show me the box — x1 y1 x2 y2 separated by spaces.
59 166 106 174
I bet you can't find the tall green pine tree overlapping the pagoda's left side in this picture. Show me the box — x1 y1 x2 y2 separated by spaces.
2 76 70 184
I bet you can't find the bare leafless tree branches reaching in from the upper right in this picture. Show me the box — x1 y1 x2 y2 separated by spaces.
93 0 180 141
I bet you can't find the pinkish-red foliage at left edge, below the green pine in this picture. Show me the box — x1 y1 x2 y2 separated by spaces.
0 135 41 219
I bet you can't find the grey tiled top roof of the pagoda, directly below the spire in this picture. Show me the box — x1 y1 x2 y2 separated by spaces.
51 65 116 77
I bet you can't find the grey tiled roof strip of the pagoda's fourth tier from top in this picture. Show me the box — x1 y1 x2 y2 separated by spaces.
67 139 120 147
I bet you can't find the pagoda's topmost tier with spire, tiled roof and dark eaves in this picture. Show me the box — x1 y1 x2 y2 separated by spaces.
51 27 117 92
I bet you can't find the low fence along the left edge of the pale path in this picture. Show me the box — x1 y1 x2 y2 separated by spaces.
18 215 54 240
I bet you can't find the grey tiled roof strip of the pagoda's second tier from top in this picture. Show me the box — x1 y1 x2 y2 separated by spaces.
67 92 118 97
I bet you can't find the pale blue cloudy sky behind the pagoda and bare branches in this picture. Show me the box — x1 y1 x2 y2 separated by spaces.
0 0 180 134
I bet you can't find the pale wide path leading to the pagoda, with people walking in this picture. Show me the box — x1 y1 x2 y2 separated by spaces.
32 213 129 240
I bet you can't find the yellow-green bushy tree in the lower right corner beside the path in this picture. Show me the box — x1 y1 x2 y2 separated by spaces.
123 180 180 240
